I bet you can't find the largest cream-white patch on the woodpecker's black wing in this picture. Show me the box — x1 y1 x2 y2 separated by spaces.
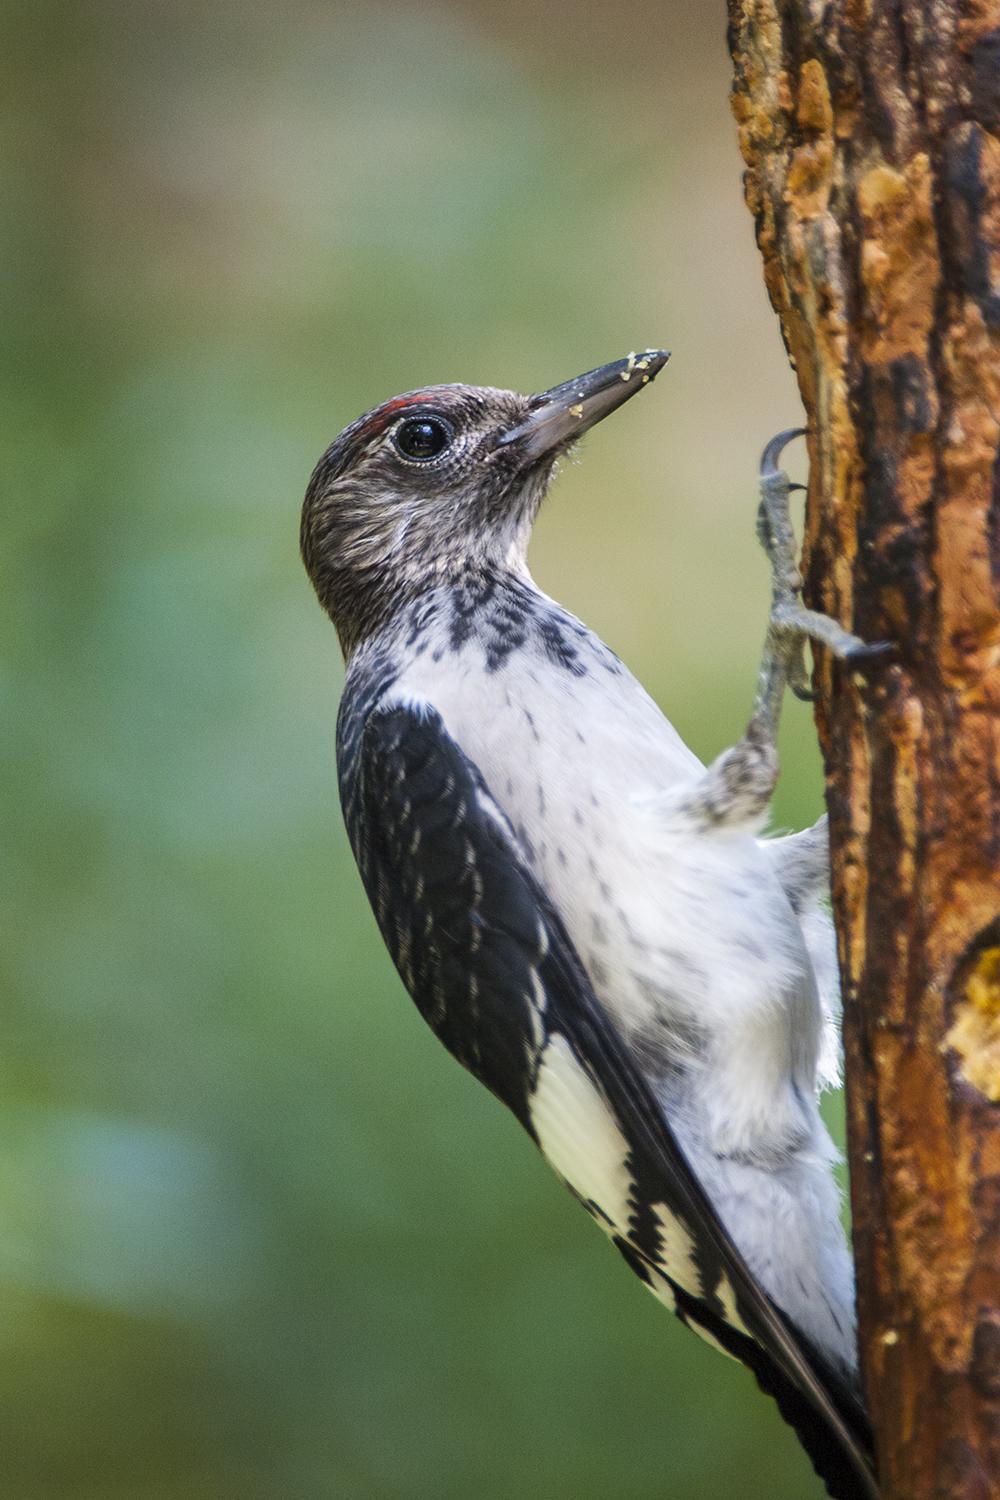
528 1034 631 1233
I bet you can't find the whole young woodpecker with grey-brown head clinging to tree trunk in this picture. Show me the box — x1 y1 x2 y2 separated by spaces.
301 350 877 1500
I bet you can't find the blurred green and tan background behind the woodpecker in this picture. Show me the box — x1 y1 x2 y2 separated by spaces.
0 0 839 1500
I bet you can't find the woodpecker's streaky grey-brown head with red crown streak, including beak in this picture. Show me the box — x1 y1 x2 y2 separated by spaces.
301 350 669 651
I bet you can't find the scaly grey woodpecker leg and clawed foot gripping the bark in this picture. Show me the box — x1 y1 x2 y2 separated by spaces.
665 428 888 827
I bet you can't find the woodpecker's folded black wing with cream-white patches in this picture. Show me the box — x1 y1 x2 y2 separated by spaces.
339 704 877 1500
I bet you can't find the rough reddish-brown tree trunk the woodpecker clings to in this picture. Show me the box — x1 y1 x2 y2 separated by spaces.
729 0 1000 1500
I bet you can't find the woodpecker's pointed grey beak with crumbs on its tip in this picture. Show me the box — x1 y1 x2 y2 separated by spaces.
499 350 670 464
